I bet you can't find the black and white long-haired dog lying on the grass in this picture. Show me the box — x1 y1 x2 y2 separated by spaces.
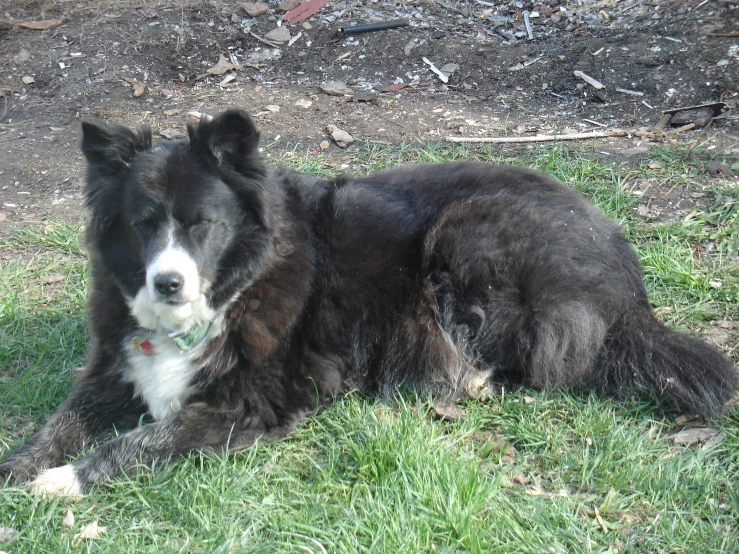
0 109 737 494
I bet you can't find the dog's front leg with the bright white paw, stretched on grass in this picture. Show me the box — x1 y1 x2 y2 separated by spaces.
29 398 294 494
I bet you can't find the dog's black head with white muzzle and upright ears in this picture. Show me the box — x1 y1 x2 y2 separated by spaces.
82 110 279 331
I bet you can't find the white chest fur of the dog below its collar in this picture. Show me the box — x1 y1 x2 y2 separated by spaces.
124 333 200 420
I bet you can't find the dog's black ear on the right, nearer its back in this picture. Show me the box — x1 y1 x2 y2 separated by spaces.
187 109 262 176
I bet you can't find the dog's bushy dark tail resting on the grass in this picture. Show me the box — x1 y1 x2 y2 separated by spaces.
592 310 737 418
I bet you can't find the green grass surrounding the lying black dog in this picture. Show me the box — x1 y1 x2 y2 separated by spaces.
0 145 739 553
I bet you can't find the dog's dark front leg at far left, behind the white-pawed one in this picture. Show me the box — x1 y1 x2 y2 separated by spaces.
0 377 144 486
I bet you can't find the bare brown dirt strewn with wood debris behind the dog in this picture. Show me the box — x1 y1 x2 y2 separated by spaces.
0 0 739 227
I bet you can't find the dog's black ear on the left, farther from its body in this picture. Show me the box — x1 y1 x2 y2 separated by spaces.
82 118 151 175
